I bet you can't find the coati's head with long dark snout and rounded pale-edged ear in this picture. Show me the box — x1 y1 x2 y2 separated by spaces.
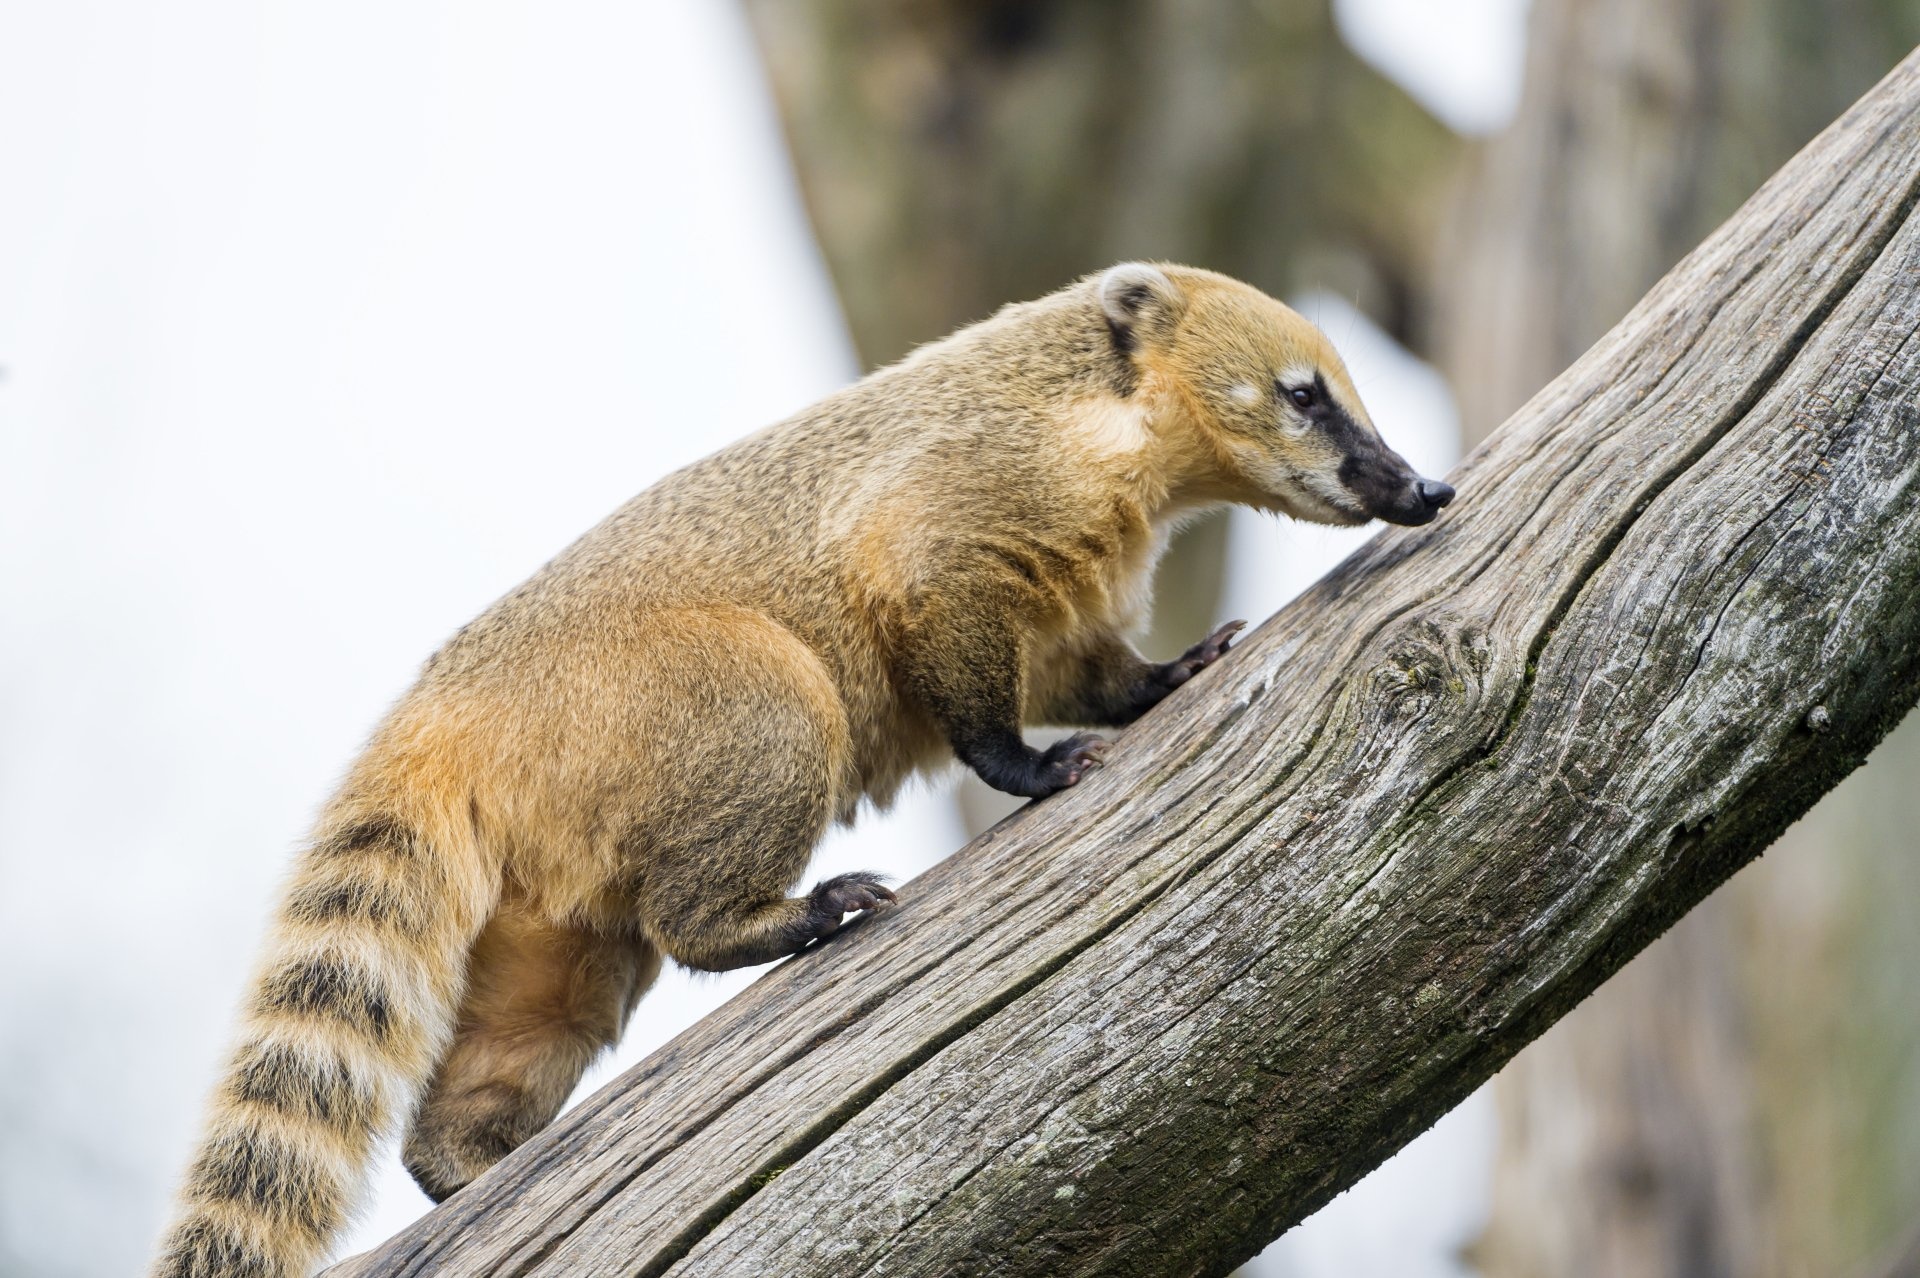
1094 263 1453 524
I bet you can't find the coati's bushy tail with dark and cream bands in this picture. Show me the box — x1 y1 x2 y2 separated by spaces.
154 814 497 1278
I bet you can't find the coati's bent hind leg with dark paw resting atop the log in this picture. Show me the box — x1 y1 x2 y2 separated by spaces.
632 608 893 971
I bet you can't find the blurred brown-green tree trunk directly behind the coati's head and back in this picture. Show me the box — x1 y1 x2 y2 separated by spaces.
747 0 1459 831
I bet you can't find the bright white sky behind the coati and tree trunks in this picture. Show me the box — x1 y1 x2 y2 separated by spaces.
0 0 1521 1278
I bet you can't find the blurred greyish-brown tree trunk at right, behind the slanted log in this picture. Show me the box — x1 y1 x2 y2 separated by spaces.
1434 0 1920 1278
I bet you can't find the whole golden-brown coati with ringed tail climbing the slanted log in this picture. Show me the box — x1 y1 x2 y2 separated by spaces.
154 263 1453 1278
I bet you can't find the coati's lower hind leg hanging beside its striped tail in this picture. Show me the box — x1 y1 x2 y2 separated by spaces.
403 902 660 1201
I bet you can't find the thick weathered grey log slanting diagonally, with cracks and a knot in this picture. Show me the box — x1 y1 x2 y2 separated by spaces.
334 56 1920 1276
